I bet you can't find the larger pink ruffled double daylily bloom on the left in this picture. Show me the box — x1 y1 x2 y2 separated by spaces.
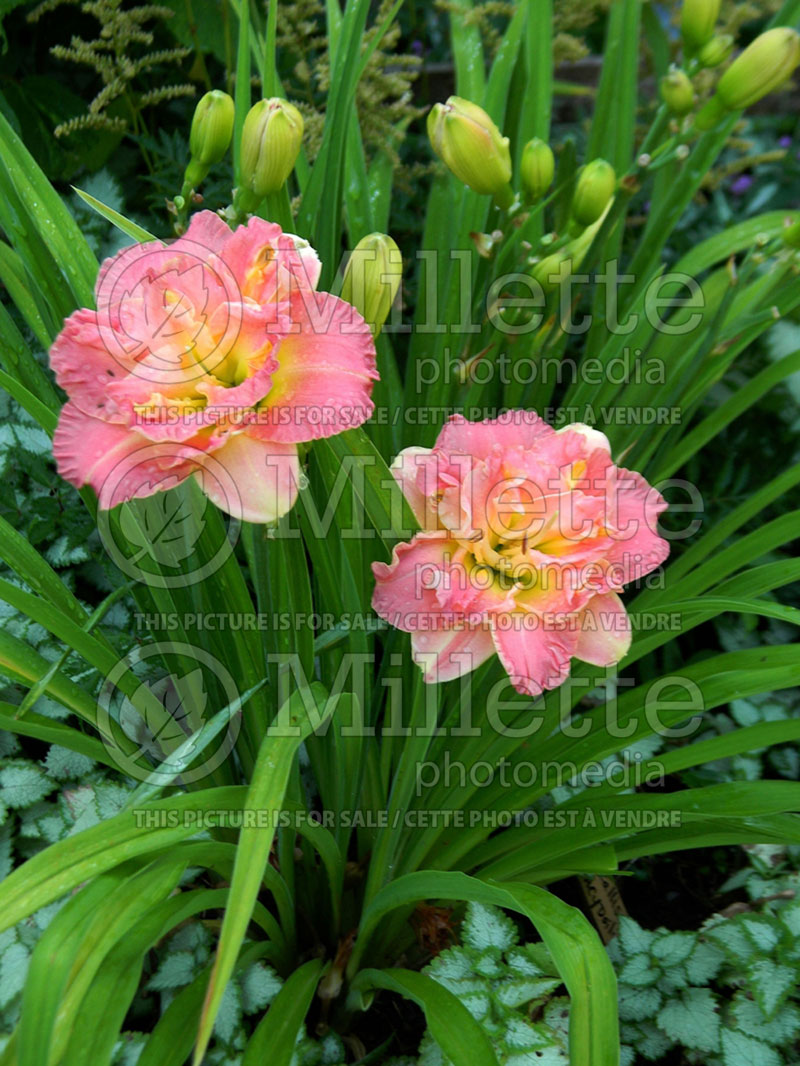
50 211 378 522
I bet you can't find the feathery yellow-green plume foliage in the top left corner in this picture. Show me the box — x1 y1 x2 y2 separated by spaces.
28 0 195 138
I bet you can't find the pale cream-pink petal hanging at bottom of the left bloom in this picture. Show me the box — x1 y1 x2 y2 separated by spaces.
197 432 300 522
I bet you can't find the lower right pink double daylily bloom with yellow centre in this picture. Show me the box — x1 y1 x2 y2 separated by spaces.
372 410 669 696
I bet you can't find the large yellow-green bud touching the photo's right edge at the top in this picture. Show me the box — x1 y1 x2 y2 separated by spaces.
717 26 800 111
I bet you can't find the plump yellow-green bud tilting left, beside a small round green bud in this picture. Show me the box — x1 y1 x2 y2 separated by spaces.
428 96 514 208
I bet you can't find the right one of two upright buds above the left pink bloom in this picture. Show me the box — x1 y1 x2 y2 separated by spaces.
241 96 303 200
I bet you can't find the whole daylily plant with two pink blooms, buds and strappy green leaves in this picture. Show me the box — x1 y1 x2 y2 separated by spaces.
0 0 800 1066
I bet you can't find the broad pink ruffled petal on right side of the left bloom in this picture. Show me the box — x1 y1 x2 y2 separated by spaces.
258 292 379 443
